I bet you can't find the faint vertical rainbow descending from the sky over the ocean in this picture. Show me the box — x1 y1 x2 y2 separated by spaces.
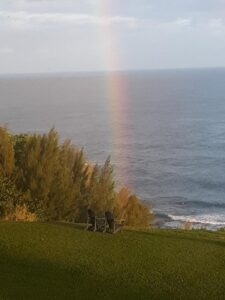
98 0 131 185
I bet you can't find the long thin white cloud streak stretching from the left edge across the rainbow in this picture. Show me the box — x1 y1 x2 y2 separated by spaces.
0 11 138 28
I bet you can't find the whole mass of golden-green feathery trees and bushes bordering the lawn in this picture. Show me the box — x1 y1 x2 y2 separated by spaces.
0 127 152 226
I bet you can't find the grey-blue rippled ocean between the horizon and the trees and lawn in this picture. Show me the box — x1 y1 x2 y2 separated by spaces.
0 69 225 229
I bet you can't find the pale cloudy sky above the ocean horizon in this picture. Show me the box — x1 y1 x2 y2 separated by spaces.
0 0 225 74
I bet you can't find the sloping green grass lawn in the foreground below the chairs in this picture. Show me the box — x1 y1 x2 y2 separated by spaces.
0 222 225 300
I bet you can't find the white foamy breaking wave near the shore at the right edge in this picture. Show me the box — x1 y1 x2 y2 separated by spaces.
169 214 225 226
